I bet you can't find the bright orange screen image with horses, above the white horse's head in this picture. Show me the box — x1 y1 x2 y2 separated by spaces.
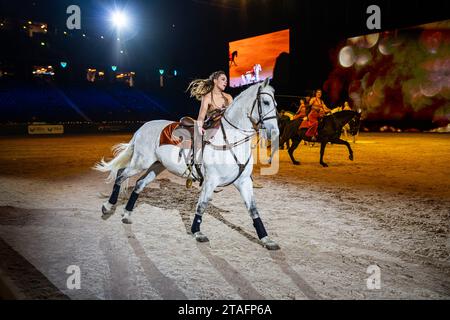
229 30 289 87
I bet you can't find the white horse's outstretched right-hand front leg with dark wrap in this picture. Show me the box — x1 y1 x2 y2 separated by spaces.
234 177 280 250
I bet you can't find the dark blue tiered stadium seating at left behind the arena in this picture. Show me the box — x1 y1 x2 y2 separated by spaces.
0 78 169 123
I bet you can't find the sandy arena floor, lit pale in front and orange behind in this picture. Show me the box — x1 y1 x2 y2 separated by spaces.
0 134 450 299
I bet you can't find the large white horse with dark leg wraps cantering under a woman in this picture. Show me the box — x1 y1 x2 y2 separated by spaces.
94 79 279 250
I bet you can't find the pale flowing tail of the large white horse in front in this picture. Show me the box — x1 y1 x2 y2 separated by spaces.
92 140 134 182
